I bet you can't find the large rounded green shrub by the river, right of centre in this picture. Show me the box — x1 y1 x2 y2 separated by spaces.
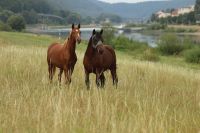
158 34 184 55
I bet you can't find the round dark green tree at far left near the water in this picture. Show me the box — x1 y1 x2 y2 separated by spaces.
8 15 25 31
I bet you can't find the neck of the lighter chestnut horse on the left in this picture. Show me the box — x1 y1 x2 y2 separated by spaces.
64 35 76 54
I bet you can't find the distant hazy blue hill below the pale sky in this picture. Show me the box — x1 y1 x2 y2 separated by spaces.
49 0 195 20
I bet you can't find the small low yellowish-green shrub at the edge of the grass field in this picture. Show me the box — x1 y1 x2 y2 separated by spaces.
142 49 160 62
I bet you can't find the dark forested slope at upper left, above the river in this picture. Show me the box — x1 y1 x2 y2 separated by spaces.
0 0 121 30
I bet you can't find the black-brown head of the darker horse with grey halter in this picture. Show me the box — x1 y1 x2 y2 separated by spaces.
91 29 104 54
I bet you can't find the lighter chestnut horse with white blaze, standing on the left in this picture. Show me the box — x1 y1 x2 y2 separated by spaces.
47 24 81 84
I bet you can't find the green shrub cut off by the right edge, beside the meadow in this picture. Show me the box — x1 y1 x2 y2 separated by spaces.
185 48 200 64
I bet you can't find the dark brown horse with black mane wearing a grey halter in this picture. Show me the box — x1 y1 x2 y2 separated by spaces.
83 29 118 89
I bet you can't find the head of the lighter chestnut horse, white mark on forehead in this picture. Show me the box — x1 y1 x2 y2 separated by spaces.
71 24 81 44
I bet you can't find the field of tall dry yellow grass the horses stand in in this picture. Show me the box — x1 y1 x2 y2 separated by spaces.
0 32 200 133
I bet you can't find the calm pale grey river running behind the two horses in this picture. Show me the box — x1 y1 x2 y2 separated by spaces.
27 28 199 47
